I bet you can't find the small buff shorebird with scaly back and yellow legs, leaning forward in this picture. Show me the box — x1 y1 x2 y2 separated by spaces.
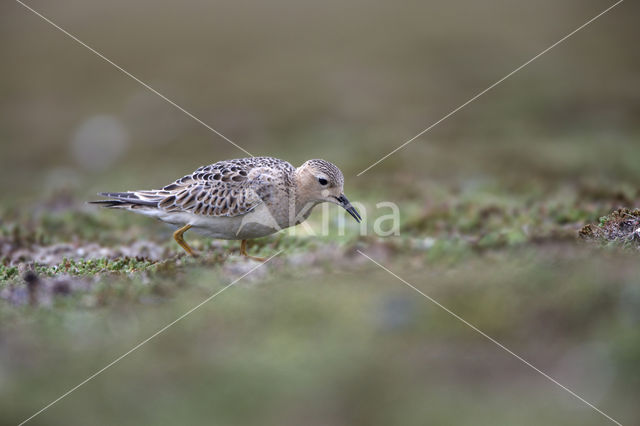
90 157 362 261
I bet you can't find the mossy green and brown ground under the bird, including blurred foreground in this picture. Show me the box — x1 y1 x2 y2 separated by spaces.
0 181 640 424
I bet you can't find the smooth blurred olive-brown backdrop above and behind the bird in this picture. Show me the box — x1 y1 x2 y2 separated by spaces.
0 0 640 196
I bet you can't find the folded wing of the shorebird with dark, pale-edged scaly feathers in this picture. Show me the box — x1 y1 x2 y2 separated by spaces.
135 161 280 217
